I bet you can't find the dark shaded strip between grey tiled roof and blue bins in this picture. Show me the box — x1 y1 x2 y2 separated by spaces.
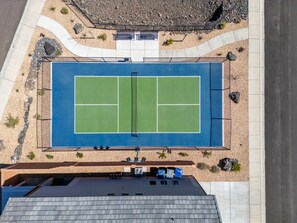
30 176 206 197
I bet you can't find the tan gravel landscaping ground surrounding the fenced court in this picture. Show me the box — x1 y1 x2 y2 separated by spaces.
0 0 249 181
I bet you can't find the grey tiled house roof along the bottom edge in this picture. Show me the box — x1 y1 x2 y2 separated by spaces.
0 195 221 223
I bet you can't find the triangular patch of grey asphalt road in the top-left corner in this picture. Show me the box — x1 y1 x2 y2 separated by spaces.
0 0 27 70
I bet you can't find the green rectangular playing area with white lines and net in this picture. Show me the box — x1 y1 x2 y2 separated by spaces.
74 76 200 133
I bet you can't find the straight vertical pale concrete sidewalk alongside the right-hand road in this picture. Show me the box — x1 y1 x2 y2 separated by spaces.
249 0 266 223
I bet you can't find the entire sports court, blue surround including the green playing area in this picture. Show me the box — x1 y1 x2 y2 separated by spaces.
51 62 223 147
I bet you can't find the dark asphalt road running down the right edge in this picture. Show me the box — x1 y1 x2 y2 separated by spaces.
265 0 297 223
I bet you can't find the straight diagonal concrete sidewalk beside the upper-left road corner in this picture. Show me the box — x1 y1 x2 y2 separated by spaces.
0 0 45 119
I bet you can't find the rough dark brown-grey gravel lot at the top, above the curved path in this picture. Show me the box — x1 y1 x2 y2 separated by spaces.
72 0 248 31
